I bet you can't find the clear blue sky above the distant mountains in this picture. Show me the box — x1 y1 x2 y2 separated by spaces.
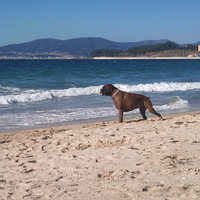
0 0 200 46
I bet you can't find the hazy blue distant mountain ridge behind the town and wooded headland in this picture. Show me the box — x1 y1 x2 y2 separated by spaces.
0 37 169 57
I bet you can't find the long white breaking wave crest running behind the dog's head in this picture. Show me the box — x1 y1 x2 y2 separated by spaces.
0 82 200 105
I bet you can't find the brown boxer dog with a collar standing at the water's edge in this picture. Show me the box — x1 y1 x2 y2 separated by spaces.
100 84 162 123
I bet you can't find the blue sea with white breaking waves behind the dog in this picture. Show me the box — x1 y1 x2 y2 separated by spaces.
0 59 200 132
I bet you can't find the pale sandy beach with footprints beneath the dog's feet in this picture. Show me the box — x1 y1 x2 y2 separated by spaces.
0 111 200 200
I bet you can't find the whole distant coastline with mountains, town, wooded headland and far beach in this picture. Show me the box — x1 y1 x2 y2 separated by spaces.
0 37 200 59
